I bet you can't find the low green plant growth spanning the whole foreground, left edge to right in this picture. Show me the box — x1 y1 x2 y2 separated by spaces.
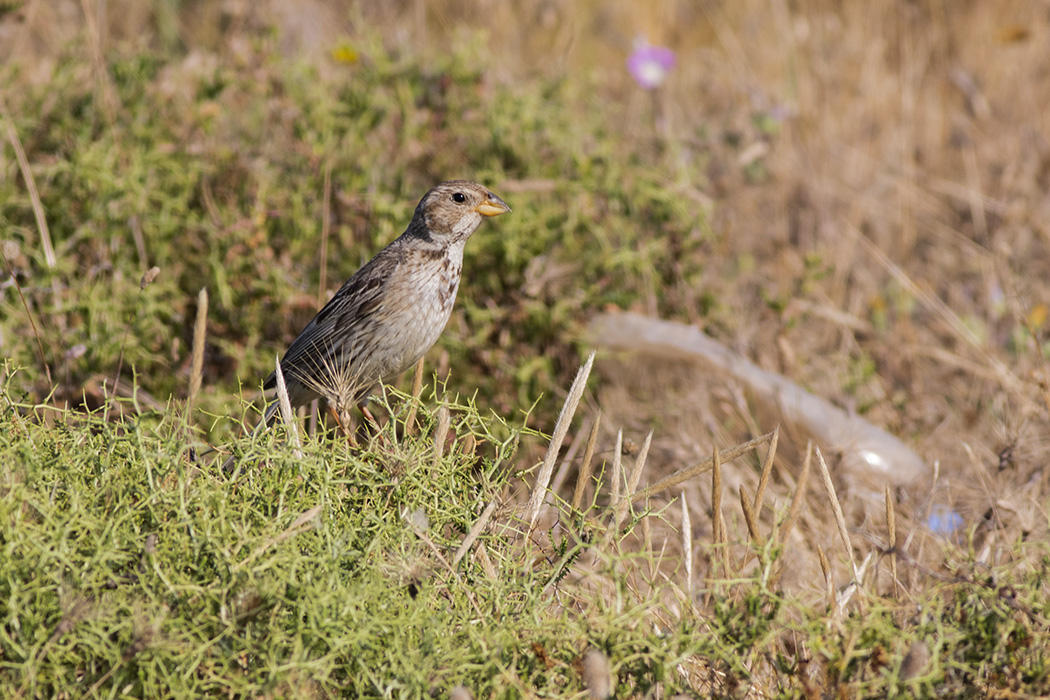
0 365 1050 698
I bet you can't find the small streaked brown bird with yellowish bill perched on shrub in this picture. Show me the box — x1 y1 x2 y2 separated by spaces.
260 179 510 425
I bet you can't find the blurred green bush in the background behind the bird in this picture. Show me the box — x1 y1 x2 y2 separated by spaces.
0 35 705 434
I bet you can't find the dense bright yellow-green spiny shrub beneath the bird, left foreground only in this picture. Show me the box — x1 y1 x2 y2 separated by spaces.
0 386 698 697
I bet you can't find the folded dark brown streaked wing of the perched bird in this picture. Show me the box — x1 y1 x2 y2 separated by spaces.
263 255 401 389
